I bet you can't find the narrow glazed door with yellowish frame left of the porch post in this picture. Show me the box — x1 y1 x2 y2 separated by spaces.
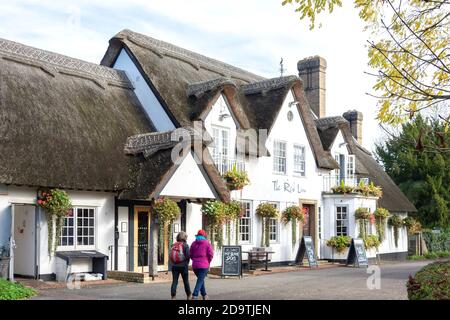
133 207 151 272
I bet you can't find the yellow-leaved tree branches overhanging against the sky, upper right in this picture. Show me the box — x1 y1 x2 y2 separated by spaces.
282 0 450 131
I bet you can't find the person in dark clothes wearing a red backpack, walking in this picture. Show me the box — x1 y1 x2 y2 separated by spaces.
169 231 192 300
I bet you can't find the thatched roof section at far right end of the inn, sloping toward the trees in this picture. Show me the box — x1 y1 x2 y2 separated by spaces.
315 116 417 212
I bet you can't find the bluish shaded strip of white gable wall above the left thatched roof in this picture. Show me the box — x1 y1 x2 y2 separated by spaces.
113 49 175 131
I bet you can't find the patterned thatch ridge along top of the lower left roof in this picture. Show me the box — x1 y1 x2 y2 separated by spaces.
0 38 131 86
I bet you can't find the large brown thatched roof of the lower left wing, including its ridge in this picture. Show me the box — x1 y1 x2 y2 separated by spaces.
0 39 154 191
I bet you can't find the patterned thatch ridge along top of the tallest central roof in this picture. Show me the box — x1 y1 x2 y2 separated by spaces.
115 29 264 82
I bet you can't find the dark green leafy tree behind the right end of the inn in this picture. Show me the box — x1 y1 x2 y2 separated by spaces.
376 115 450 228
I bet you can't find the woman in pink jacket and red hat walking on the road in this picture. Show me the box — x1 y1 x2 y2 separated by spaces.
189 230 214 300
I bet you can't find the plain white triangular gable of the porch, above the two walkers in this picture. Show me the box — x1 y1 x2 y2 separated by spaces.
160 153 215 199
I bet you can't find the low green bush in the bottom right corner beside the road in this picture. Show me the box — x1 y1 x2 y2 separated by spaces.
406 261 450 300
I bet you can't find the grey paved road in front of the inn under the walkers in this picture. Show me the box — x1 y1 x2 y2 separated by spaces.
35 261 429 300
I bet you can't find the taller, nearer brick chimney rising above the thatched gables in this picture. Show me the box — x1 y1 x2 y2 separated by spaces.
297 56 327 118
